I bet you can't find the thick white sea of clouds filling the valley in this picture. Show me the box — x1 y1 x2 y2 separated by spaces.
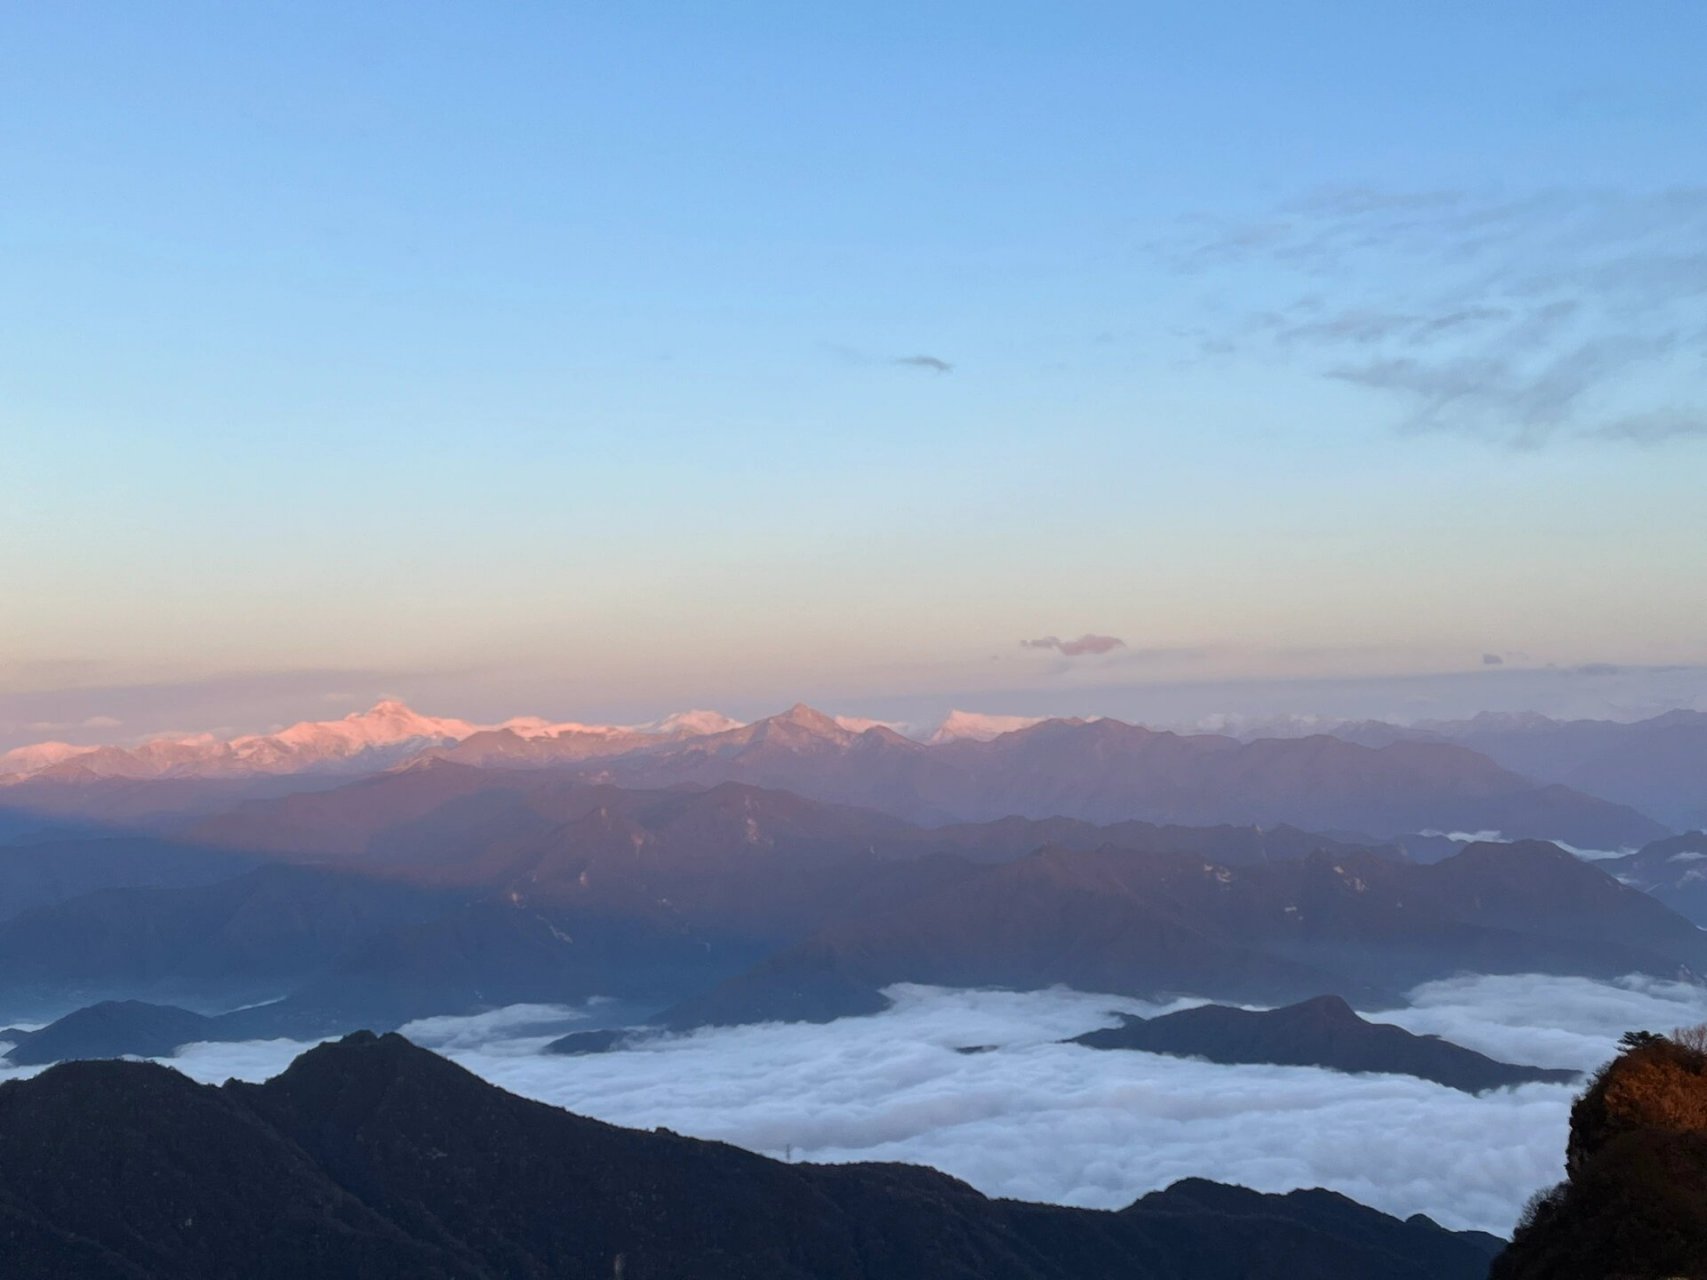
0 976 1707 1234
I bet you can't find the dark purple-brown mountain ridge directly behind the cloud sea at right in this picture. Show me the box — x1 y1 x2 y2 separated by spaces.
666 841 1707 1027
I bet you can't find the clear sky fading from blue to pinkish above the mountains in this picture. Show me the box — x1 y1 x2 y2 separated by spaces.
0 0 1707 741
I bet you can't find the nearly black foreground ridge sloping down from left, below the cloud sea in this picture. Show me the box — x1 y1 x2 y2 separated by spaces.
0 1033 1499 1280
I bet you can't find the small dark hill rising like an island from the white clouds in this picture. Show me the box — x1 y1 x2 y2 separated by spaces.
1074 995 1577 1094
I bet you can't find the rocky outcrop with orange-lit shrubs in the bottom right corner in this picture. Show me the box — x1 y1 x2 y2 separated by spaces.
1490 1039 1707 1280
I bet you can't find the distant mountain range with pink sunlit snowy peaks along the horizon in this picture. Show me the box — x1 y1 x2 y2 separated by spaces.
0 703 1669 848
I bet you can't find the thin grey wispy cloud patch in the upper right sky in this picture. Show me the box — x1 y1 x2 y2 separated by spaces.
1164 188 1707 449
